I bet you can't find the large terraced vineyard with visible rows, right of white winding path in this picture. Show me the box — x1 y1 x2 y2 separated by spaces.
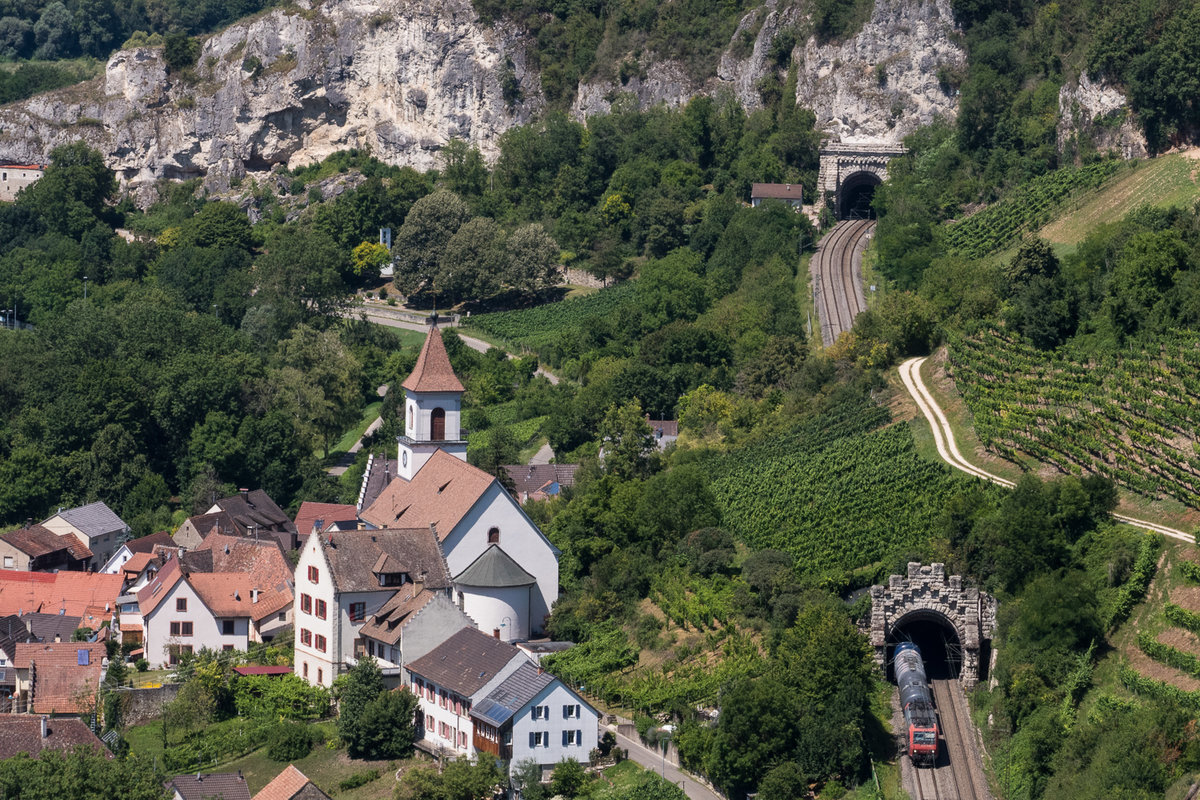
949 330 1200 509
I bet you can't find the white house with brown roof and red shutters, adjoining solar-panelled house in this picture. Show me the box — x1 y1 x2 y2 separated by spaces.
404 627 528 758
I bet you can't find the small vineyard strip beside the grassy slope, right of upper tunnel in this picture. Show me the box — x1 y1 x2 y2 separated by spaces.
946 160 1121 258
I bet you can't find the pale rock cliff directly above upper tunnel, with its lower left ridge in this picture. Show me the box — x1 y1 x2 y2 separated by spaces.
575 0 966 142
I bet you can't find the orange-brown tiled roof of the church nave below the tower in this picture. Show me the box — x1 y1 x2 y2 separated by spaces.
362 450 496 541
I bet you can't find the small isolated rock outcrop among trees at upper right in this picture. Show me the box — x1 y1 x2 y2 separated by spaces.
1057 73 1147 158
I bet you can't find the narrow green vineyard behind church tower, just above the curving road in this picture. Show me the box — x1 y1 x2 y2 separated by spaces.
463 282 637 354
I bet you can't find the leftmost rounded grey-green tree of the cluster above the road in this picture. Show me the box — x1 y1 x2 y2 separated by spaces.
392 190 470 294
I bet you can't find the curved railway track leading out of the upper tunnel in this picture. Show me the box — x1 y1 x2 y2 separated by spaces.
810 219 875 347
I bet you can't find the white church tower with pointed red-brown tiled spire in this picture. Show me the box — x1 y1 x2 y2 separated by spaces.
397 319 467 481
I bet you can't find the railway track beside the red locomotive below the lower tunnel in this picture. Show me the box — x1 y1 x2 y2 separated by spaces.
902 680 991 800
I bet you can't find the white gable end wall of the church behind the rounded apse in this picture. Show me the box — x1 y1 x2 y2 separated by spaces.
442 481 558 638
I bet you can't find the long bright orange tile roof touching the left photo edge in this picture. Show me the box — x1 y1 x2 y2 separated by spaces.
0 572 125 619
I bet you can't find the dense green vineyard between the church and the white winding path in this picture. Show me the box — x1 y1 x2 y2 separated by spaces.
710 404 974 575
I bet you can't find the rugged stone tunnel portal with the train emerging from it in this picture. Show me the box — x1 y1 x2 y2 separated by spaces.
870 561 996 688
